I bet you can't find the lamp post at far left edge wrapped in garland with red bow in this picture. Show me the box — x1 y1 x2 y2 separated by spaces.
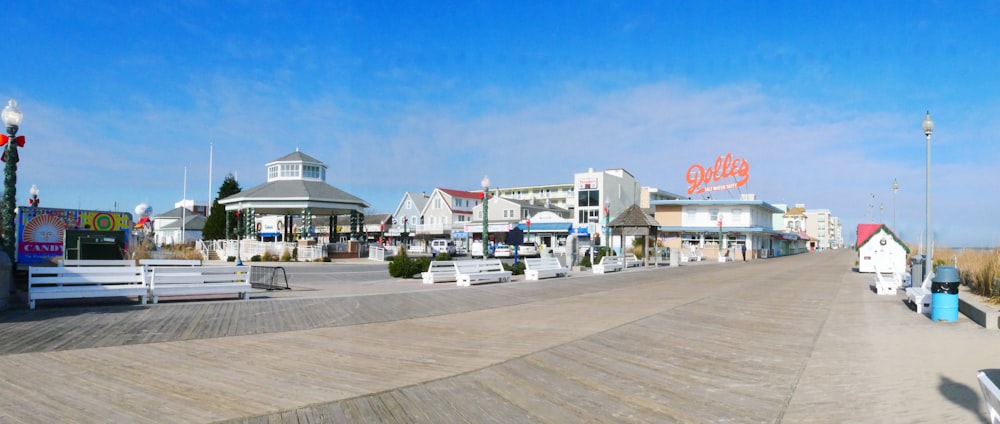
0 99 24 264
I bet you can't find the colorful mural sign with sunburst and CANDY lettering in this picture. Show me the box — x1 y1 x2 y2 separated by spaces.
17 207 132 265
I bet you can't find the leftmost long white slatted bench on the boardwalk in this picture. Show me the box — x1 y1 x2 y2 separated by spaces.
28 265 149 309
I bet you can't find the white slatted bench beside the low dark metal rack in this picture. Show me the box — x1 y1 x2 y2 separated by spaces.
149 265 250 303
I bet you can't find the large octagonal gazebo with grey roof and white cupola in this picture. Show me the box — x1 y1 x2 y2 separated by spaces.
219 149 370 255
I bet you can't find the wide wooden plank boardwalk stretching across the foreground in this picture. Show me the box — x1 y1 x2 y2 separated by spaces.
0 251 1000 423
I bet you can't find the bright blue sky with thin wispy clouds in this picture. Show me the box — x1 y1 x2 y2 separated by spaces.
0 0 1000 247
